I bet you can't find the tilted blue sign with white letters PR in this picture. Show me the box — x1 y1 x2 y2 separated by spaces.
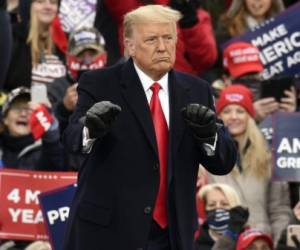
39 184 76 250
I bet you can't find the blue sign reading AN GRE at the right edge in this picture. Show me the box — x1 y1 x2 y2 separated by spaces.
273 112 300 181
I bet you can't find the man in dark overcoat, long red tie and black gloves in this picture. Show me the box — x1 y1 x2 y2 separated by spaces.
63 5 236 250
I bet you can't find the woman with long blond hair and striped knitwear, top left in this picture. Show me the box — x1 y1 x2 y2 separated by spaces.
4 0 66 90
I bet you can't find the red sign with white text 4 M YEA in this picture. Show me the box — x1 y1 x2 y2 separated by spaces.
0 169 77 240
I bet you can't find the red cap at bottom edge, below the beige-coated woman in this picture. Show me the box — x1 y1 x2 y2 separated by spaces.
236 229 273 250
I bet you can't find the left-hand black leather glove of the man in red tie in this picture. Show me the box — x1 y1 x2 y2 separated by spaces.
84 101 122 138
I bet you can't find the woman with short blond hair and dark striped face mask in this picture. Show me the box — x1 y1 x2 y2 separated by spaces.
196 183 249 250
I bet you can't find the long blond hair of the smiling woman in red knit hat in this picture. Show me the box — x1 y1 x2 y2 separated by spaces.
232 116 272 179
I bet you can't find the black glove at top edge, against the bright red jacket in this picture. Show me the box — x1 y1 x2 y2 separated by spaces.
170 0 199 28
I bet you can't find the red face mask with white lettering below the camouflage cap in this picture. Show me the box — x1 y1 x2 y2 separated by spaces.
67 53 107 80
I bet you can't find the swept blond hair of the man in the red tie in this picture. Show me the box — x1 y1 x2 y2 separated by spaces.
123 4 181 38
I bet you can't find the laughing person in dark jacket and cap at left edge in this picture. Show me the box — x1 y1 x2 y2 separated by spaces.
0 87 65 250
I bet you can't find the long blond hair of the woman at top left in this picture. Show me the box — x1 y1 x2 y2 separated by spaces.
27 5 54 66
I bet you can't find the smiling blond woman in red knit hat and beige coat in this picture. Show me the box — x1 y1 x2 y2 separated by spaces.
204 84 291 244
